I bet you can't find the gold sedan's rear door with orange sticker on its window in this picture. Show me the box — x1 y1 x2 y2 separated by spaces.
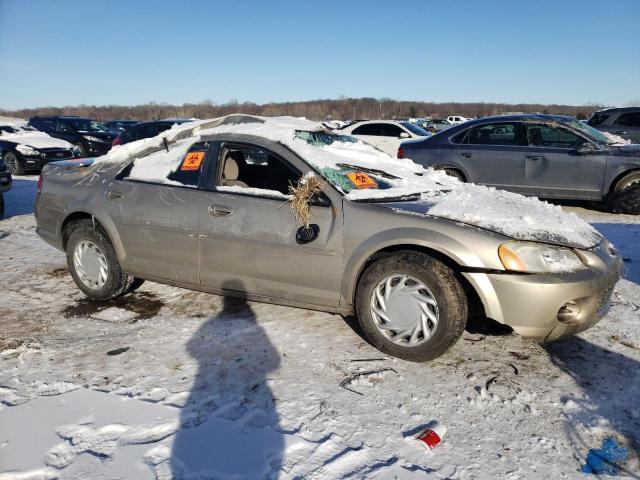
100 142 209 285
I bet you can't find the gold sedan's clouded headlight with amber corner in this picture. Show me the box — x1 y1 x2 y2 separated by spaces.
498 241 587 273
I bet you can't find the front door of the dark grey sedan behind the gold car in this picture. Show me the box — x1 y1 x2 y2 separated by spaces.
524 122 607 200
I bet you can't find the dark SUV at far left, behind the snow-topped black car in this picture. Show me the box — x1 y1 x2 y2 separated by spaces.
28 116 116 157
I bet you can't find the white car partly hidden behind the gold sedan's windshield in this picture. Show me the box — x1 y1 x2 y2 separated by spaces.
338 120 431 156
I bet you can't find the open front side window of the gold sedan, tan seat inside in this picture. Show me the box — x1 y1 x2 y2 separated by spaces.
217 144 301 195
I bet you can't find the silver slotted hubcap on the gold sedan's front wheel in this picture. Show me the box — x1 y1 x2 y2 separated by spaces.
371 274 439 347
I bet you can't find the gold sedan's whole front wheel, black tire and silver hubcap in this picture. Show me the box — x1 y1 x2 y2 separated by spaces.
356 251 467 362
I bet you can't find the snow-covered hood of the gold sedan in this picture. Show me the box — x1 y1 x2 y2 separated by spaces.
368 184 602 249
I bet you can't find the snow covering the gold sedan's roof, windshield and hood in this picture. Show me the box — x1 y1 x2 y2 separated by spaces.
95 115 601 248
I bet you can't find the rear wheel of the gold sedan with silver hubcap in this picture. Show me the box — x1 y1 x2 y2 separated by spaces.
66 220 135 300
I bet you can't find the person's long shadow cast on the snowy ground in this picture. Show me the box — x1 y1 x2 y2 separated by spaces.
170 281 284 480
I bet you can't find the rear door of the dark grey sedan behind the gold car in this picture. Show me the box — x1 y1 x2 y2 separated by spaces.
452 122 524 192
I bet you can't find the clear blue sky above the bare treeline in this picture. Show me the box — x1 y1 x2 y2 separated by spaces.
0 0 640 109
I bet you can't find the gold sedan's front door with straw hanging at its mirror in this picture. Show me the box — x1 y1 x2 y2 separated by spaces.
198 140 342 307
